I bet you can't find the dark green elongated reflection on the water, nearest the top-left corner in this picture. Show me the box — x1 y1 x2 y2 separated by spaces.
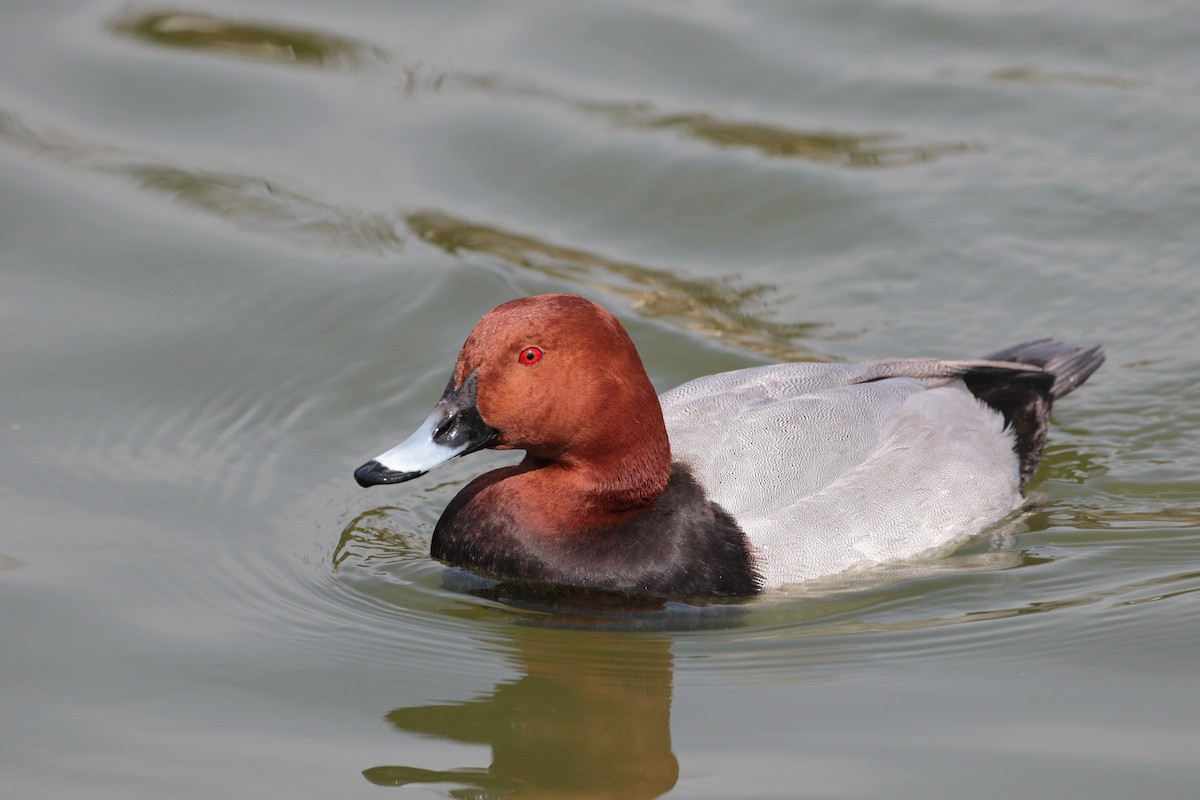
112 11 386 66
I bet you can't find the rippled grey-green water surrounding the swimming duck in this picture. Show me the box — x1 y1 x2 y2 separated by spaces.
0 0 1200 800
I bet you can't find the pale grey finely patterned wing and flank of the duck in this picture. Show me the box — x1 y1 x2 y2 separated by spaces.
660 360 1036 587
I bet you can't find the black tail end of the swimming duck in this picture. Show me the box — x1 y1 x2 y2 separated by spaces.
962 339 1104 485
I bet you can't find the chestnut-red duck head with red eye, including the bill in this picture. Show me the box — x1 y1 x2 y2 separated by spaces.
354 294 671 507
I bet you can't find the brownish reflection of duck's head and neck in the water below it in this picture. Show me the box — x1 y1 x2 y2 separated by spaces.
362 626 679 799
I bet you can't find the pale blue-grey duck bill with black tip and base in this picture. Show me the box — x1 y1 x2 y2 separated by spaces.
354 369 499 486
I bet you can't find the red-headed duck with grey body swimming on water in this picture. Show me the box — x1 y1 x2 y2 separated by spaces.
354 294 1104 599
